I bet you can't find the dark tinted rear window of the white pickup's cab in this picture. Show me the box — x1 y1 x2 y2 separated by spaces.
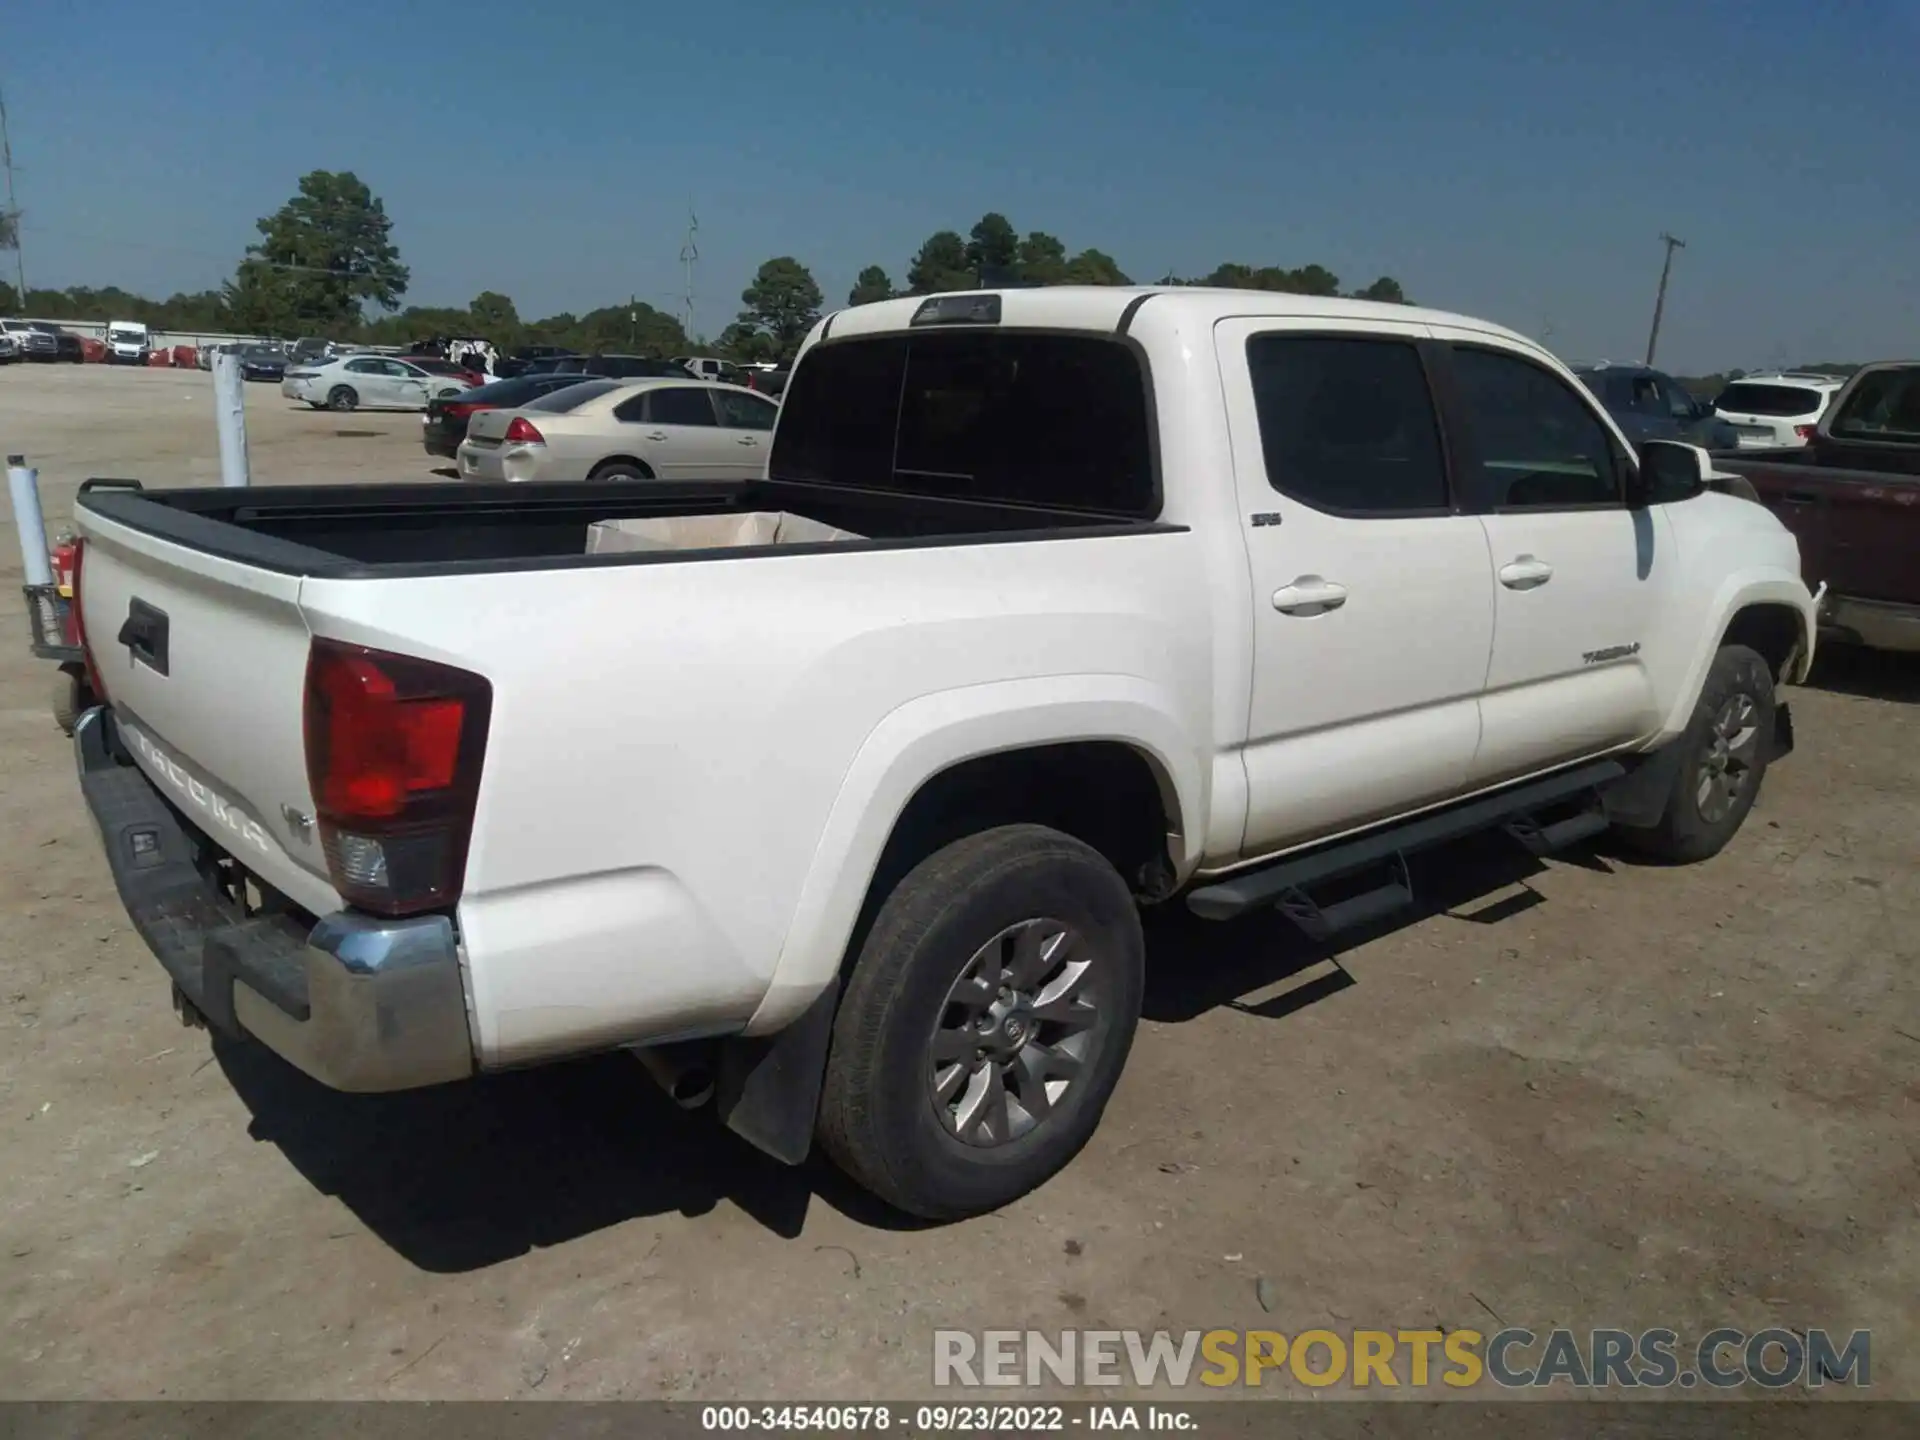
768 330 1160 516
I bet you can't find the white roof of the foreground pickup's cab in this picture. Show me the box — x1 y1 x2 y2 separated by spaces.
814 284 1540 349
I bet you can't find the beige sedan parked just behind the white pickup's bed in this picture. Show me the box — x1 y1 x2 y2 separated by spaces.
459 378 780 482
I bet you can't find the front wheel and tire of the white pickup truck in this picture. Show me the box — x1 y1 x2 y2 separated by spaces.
1619 645 1776 864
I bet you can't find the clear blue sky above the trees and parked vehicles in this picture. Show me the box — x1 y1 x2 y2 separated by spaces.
0 0 1920 371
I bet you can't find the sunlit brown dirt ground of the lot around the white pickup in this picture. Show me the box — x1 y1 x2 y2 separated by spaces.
0 367 1920 1400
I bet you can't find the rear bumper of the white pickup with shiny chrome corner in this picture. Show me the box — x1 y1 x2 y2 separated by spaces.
73 707 474 1091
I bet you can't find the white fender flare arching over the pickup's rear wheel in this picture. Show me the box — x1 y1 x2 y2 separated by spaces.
743 674 1208 1035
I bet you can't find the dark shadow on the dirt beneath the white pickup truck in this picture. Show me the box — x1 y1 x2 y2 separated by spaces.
215 835 1603 1271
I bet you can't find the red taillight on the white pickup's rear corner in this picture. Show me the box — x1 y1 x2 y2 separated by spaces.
305 639 493 916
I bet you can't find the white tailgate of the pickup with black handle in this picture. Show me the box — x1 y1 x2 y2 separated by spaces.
77 511 340 914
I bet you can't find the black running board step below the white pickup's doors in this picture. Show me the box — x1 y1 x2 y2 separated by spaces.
1187 760 1626 924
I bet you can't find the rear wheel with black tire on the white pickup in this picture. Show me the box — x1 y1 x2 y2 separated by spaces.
818 826 1146 1219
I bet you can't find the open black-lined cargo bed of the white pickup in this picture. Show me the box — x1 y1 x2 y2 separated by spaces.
79 480 1177 580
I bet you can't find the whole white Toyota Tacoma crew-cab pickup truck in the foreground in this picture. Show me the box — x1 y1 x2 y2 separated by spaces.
75 288 1814 1217
